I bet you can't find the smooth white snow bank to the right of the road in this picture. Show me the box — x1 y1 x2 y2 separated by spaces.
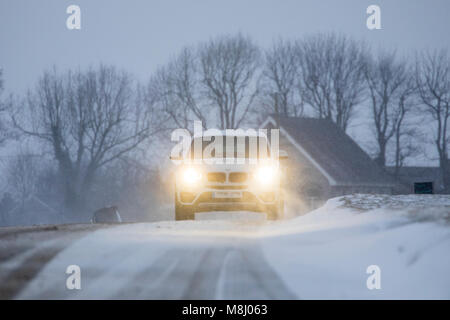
261 194 450 299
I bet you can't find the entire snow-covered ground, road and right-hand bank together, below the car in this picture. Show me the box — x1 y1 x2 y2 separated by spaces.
0 196 450 299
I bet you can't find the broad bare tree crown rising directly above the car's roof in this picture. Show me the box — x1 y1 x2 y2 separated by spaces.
152 34 260 129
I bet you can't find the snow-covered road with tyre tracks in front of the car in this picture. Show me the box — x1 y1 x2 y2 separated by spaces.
9 221 295 299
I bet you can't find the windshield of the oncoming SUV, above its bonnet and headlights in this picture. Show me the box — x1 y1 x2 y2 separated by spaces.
190 136 270 159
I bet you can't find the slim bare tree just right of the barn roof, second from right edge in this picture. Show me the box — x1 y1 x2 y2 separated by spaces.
365 52 413 166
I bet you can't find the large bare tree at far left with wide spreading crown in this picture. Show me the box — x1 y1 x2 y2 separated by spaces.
12 65 163 214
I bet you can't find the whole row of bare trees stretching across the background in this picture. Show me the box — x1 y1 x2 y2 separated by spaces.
0 34 450 222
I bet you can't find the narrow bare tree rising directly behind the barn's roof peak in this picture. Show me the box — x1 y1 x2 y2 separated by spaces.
260 39 303 122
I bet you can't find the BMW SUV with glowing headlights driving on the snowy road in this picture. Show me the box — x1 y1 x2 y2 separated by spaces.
171 134 287 220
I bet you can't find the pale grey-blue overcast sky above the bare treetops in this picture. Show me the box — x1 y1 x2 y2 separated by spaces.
0 0 450 93
